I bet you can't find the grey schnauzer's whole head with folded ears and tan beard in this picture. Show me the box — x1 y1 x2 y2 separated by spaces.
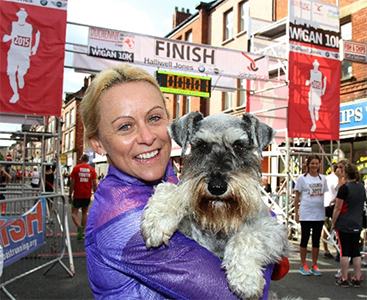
169 112 275 230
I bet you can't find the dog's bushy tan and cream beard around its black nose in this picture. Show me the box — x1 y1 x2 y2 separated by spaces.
181 172 262 235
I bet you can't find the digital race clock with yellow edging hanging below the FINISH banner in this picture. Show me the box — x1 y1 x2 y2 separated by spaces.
156 71 211 98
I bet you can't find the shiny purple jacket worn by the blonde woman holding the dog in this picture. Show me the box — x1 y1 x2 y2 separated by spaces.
85 164 273 300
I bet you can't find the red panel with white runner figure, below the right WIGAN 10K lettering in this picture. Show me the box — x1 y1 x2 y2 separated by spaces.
288 52 340 140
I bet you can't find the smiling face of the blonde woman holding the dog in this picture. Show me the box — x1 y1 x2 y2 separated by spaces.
91 82 171 181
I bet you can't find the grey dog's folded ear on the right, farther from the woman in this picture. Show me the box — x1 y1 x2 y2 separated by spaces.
242 113 276 159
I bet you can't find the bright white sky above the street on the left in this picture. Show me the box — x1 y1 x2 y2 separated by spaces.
0 0 203 146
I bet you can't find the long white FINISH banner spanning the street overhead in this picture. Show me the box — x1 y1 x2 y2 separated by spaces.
88 27 269 80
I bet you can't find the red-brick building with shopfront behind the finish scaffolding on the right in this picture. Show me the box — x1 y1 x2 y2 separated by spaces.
166 0 367 179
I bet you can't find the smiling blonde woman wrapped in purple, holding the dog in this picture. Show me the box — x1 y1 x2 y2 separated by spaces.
82 64 272 299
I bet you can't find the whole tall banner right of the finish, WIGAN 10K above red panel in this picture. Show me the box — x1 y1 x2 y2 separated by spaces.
287 0 340 140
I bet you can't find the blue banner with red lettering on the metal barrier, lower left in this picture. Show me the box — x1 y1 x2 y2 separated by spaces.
0 197 46 267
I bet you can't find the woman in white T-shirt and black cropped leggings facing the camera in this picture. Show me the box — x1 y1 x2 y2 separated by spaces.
294 154 327 276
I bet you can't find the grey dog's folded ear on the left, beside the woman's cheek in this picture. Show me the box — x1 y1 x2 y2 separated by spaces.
168 111 204 156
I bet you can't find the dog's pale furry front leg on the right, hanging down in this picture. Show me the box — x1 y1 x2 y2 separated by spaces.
223 211 291 299
